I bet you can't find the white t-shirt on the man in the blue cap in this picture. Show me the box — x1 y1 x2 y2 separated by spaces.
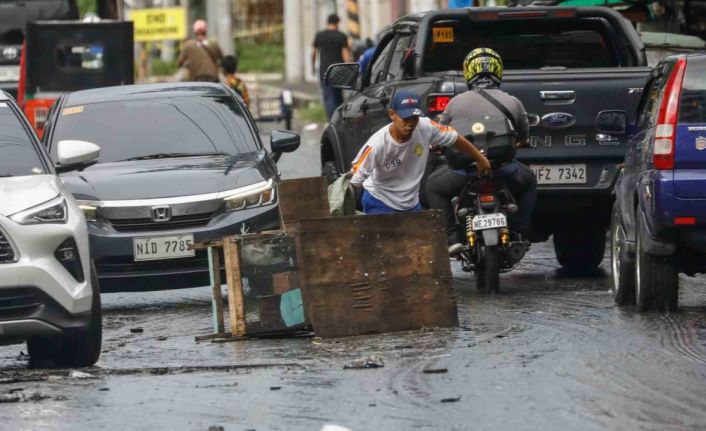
351 117 458 211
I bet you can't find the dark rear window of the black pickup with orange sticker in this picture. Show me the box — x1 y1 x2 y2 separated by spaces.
424 18 619 73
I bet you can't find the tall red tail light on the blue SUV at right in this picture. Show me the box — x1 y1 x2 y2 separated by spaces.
652 58 686 169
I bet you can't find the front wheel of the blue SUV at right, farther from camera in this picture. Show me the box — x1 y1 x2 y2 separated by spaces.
610 205 635 305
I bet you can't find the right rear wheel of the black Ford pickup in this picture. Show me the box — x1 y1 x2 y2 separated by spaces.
553 226 606 275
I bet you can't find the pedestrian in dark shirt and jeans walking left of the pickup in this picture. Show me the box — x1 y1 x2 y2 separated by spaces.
311 14 353 120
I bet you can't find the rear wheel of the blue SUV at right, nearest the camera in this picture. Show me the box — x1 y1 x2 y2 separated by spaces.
635 218 679 313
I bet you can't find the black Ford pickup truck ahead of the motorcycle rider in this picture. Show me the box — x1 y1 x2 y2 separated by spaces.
321 7 650 272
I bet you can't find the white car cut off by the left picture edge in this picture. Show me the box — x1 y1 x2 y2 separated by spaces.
0 92 102 366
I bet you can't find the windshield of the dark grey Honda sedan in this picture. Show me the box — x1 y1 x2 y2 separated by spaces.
51 96 262 163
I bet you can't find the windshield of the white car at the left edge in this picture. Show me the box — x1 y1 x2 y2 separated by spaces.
0 102 46 177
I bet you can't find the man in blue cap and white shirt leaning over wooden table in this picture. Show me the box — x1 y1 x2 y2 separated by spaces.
351 91 491 214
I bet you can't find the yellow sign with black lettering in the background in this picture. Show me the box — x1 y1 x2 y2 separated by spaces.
130 7 186 42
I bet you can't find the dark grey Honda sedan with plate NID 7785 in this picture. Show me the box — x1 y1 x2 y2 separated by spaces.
44 83 300 292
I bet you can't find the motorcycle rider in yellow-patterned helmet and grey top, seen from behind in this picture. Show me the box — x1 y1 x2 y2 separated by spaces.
424 48 537 255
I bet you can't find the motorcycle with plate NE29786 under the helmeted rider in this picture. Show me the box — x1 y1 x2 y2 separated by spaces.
456 166 530 292
